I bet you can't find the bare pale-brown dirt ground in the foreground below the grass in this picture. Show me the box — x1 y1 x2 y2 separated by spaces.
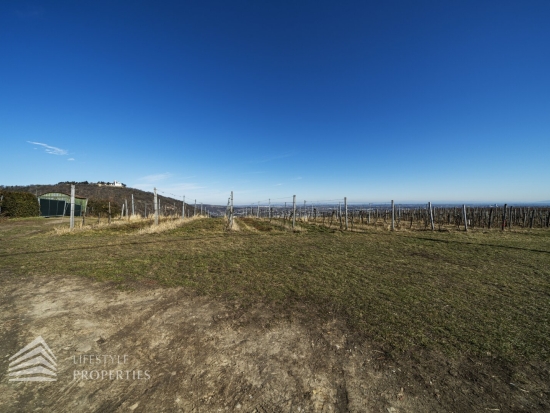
0 276 544 412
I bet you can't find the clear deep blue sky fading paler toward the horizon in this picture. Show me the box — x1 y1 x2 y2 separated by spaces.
0 1 550 204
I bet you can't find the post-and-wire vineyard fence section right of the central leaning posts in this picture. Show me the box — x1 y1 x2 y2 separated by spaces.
221 196 550 231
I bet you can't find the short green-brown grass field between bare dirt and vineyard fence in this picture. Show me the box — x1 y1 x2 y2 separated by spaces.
0 214 550 364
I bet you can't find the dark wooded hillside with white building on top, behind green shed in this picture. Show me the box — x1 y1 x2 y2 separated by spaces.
0 183 193 214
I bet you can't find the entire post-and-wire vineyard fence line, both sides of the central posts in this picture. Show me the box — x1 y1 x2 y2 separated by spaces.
82 188 550 231
